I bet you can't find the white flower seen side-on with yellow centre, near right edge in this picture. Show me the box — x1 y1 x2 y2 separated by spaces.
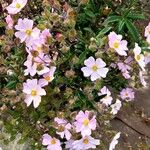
133 43 145 71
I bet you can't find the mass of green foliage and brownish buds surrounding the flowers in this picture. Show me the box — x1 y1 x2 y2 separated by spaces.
0 0 150 149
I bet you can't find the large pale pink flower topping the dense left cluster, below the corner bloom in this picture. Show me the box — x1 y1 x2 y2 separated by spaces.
15 18 40 47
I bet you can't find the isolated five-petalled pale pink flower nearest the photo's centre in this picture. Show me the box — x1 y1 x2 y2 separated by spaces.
81 57 108 81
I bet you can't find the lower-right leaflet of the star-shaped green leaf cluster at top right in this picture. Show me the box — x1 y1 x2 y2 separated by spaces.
125 20 140 42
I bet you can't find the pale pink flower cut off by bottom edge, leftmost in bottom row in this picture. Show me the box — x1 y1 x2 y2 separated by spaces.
42 134 62 150
